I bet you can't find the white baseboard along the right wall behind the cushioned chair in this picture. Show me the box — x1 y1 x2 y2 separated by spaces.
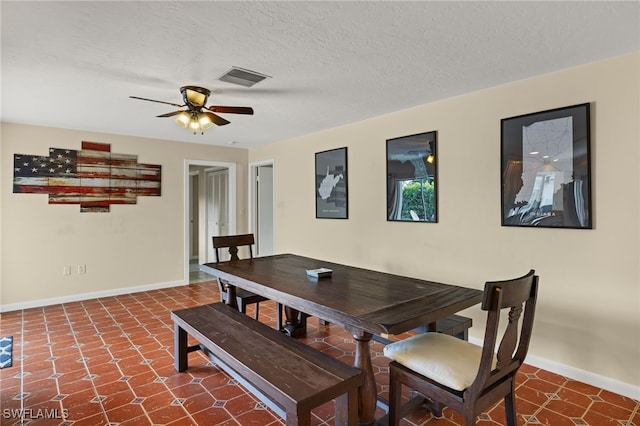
469 337 640 401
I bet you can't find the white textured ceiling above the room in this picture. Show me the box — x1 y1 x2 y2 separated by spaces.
0 1 640 147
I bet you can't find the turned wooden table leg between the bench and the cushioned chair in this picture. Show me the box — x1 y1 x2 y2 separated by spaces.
352 331 378 425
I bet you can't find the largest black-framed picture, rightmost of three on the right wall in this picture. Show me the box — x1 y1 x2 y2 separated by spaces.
501 103 592 229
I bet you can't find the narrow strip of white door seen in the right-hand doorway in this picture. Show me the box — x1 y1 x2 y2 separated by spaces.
256 165 273 256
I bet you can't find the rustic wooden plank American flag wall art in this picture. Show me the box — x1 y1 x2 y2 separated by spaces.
13 142 162 212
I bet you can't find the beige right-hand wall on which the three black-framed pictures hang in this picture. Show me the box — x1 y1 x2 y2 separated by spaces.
249 54 640 398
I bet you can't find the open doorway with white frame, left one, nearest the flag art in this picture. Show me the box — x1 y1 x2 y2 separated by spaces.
184 160 236 282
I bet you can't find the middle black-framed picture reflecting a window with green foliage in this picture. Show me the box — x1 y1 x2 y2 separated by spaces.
387 131 438 222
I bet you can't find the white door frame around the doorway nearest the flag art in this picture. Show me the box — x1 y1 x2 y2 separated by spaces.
183 159 238 284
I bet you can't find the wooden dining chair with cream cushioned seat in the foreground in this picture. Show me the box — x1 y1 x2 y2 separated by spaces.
384 270 538 426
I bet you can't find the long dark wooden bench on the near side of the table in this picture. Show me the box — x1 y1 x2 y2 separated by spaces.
171 303 364 426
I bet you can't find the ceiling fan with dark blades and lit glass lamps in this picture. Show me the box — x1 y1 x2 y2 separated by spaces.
129 86 253 135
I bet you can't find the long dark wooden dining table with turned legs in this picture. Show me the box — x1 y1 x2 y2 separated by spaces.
200 254 482 425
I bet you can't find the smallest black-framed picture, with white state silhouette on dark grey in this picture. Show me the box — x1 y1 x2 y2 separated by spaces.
316 147 349 219
